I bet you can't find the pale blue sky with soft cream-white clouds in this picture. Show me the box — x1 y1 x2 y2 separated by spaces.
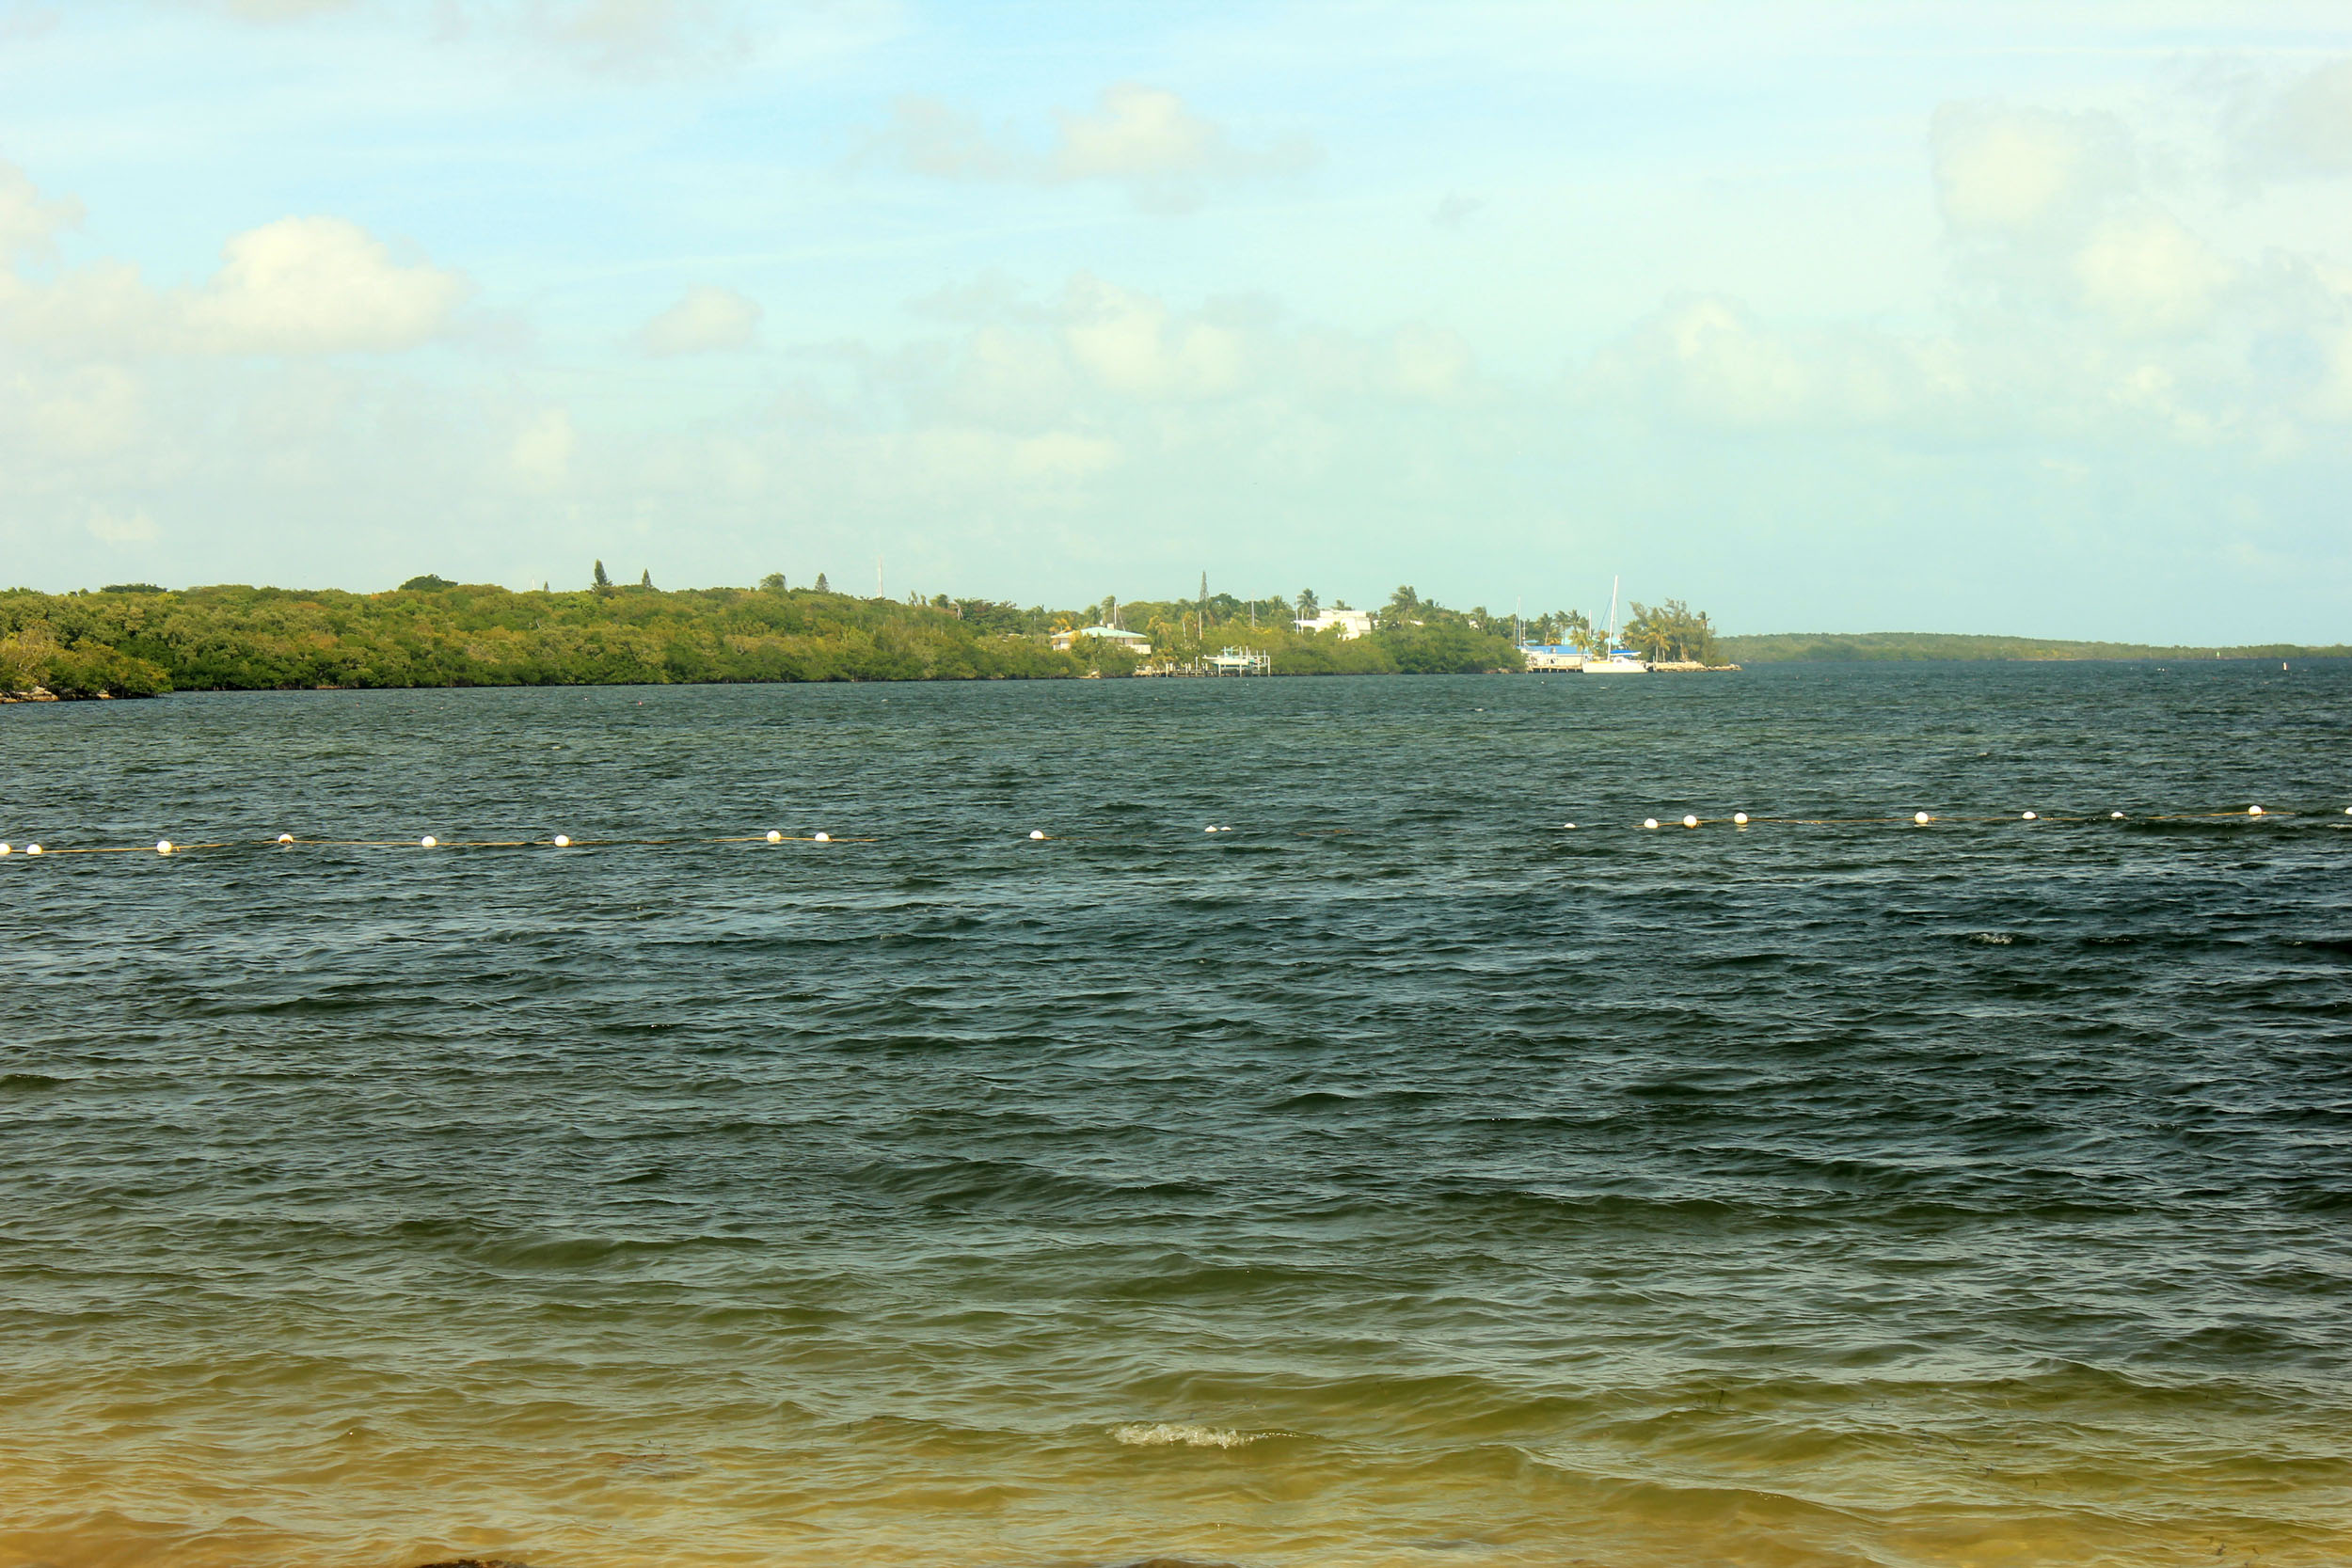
0 0 2352 641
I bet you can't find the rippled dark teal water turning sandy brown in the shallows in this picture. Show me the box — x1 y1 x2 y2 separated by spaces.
0 663 2352 1568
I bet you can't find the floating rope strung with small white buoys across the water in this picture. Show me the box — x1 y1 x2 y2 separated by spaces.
0 806 2352 861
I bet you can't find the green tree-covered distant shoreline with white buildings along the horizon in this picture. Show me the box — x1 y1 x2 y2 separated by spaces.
0 578 2352 703
